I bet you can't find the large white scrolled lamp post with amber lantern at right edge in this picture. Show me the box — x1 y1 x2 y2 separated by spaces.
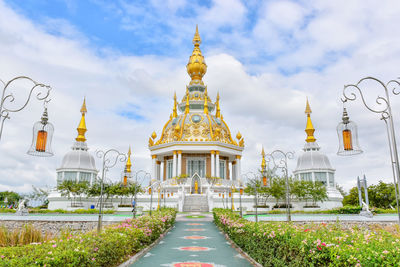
337 77 400 224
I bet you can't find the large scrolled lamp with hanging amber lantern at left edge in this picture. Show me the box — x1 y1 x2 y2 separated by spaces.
0 76 54 156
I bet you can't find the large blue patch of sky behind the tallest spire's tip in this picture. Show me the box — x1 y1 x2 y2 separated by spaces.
6 0 338 75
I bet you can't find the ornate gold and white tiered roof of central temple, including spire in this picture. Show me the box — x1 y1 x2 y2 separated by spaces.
149 26 244 150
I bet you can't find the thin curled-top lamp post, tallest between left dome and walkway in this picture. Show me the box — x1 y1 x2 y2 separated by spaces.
96 149 127 233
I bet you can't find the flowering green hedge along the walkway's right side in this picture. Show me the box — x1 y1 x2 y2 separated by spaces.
214 209 400 266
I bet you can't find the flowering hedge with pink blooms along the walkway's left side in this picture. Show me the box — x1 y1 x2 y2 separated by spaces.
0 209 176 266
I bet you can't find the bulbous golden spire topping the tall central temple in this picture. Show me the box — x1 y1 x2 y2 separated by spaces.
186 25 207 85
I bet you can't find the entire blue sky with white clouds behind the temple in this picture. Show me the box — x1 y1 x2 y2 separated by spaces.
0 0 400 192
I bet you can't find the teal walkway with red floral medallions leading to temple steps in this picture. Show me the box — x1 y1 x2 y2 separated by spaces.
131 213 252 267
